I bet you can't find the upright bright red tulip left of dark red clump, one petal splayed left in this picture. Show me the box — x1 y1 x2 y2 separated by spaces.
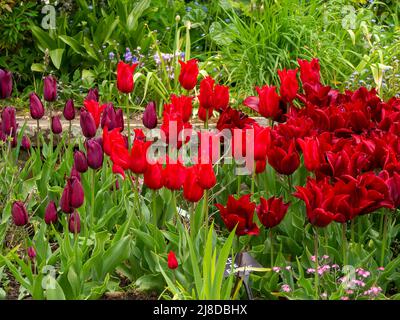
256 85 282 120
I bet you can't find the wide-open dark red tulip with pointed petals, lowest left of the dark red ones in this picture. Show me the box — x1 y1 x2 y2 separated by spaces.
215 195 259 236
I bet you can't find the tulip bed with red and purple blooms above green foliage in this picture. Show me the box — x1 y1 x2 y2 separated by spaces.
0 0 400 300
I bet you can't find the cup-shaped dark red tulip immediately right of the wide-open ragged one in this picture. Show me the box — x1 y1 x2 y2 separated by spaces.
256 197 289 228
